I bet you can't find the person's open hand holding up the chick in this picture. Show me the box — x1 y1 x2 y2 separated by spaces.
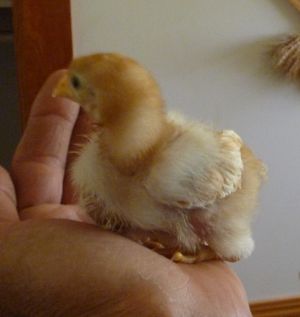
0 72 251 317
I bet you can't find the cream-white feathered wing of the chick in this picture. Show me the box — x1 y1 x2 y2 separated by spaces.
144 116 243 209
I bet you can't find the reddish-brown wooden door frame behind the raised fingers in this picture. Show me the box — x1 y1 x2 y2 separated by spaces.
12 0 73 128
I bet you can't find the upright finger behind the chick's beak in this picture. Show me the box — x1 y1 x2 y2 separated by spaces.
12 71 79 209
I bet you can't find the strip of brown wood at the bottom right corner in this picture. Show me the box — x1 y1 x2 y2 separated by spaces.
250 297 300 317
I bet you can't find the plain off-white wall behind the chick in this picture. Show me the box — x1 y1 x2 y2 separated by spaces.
72 0 300 300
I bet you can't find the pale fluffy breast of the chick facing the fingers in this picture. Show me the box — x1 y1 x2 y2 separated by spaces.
71 134 172 230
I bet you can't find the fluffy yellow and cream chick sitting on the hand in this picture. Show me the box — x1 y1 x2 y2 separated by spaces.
53 53 265 263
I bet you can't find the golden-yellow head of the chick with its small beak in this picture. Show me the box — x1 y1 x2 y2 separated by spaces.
53 53 163 124
